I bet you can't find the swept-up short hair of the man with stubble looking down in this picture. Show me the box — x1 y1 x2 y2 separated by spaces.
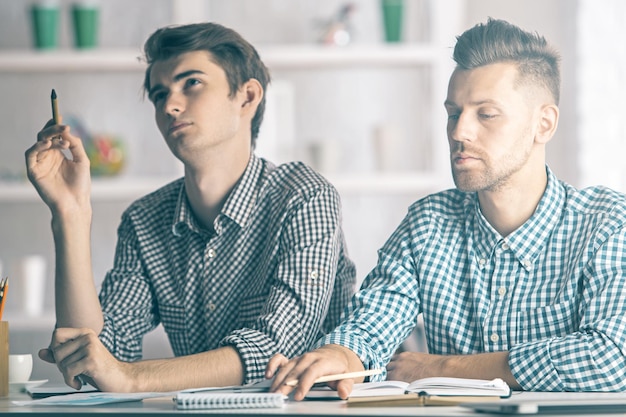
453 18 561 104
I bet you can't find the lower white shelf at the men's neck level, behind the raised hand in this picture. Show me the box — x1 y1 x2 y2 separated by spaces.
0 172 445 203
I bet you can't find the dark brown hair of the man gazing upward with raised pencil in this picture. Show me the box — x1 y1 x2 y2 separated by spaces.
143 22 270 147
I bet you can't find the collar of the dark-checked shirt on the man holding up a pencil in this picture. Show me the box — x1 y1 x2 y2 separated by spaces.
172 154 263 236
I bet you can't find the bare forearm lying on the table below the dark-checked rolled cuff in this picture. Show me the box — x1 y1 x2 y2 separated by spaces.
128 346 244 392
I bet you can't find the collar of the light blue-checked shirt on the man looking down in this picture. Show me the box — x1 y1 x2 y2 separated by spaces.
466 166 566 269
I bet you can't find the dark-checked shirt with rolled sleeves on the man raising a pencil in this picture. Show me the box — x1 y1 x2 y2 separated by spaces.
100 155 355 383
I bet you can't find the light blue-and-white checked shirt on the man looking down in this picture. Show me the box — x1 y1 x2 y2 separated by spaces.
316 169 626 391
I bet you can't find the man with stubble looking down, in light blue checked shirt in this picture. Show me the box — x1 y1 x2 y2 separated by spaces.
266 19 626 399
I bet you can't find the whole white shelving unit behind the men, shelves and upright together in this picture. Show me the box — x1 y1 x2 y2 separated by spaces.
0 0 464 333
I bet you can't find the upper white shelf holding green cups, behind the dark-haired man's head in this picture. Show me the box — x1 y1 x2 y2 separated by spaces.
0 44 447 73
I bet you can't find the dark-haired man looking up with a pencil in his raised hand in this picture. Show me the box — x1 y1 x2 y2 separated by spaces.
26 23 355 392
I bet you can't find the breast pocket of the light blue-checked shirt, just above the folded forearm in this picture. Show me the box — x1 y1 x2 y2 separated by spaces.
511 303 575 344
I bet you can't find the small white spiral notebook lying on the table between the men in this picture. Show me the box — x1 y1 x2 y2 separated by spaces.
174 392 286 410
